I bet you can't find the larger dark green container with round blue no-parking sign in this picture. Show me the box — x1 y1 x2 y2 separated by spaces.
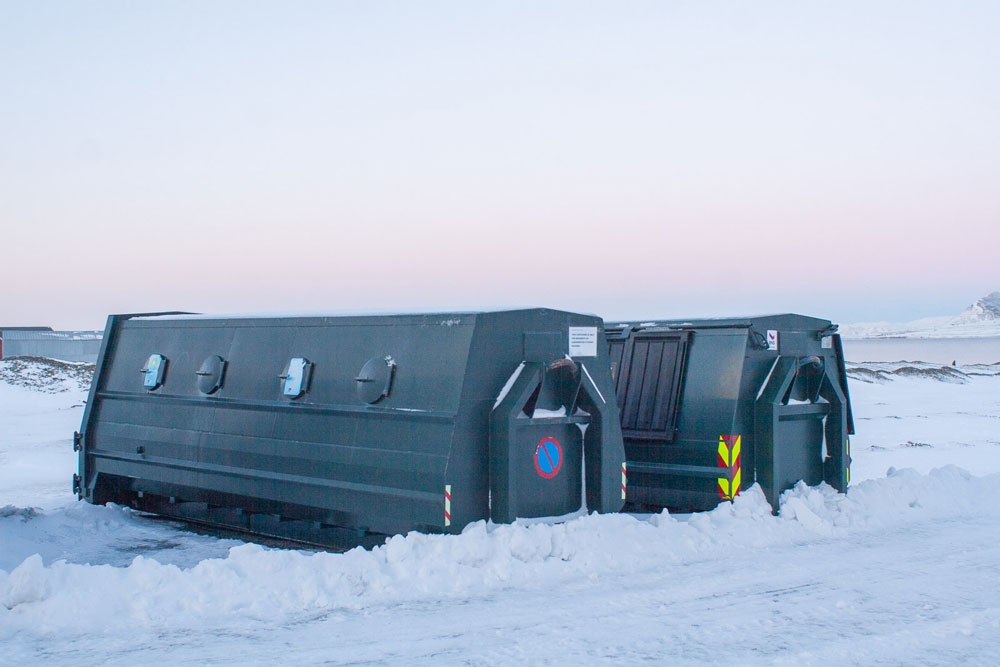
74 309 625 546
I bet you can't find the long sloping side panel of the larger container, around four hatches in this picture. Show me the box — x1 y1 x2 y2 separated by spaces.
88 316 475 532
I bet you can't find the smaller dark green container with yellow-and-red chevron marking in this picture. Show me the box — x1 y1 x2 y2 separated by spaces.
606 314 854 511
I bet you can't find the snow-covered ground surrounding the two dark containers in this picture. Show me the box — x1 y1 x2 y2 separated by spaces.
0 362 1000 665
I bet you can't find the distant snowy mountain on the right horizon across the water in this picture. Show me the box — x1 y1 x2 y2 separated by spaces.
840 292 1000 339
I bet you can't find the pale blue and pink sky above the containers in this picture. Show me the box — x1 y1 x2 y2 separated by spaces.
0 0 1000 328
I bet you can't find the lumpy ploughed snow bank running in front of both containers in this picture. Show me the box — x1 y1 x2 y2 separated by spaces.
0 466 1000 640
